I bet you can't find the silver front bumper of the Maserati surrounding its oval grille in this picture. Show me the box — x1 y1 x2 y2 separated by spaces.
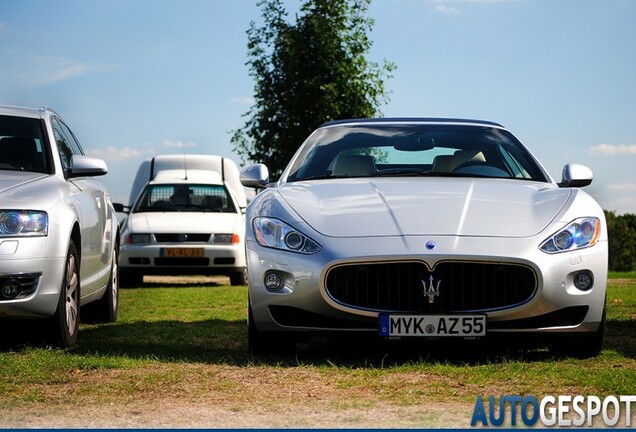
247 236 607 334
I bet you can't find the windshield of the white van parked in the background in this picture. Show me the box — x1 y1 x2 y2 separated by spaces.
132 184 236 213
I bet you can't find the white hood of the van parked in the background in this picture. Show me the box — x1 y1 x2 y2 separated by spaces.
127 212 245 234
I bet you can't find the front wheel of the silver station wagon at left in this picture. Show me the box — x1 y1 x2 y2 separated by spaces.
50 240 80 348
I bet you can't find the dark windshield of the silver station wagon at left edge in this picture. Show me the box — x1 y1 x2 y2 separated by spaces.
0 115 50 174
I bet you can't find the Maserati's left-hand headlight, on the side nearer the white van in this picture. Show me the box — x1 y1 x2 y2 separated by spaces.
253 217 322 254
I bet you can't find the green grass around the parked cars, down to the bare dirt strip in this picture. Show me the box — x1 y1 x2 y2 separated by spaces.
0 276 636 425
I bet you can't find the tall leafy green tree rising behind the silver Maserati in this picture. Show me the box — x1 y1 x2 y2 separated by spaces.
231 0 395 177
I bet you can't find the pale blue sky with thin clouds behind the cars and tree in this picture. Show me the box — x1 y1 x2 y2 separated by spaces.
0 0 636 214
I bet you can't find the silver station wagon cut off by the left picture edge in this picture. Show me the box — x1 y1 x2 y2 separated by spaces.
0 106 119 347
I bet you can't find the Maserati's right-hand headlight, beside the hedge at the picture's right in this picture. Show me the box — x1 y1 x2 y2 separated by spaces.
541 217 601 253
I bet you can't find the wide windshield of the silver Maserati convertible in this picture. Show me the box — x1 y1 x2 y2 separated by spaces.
287 123 549 182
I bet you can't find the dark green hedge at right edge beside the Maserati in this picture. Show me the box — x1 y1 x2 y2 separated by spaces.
605 211 636 271
